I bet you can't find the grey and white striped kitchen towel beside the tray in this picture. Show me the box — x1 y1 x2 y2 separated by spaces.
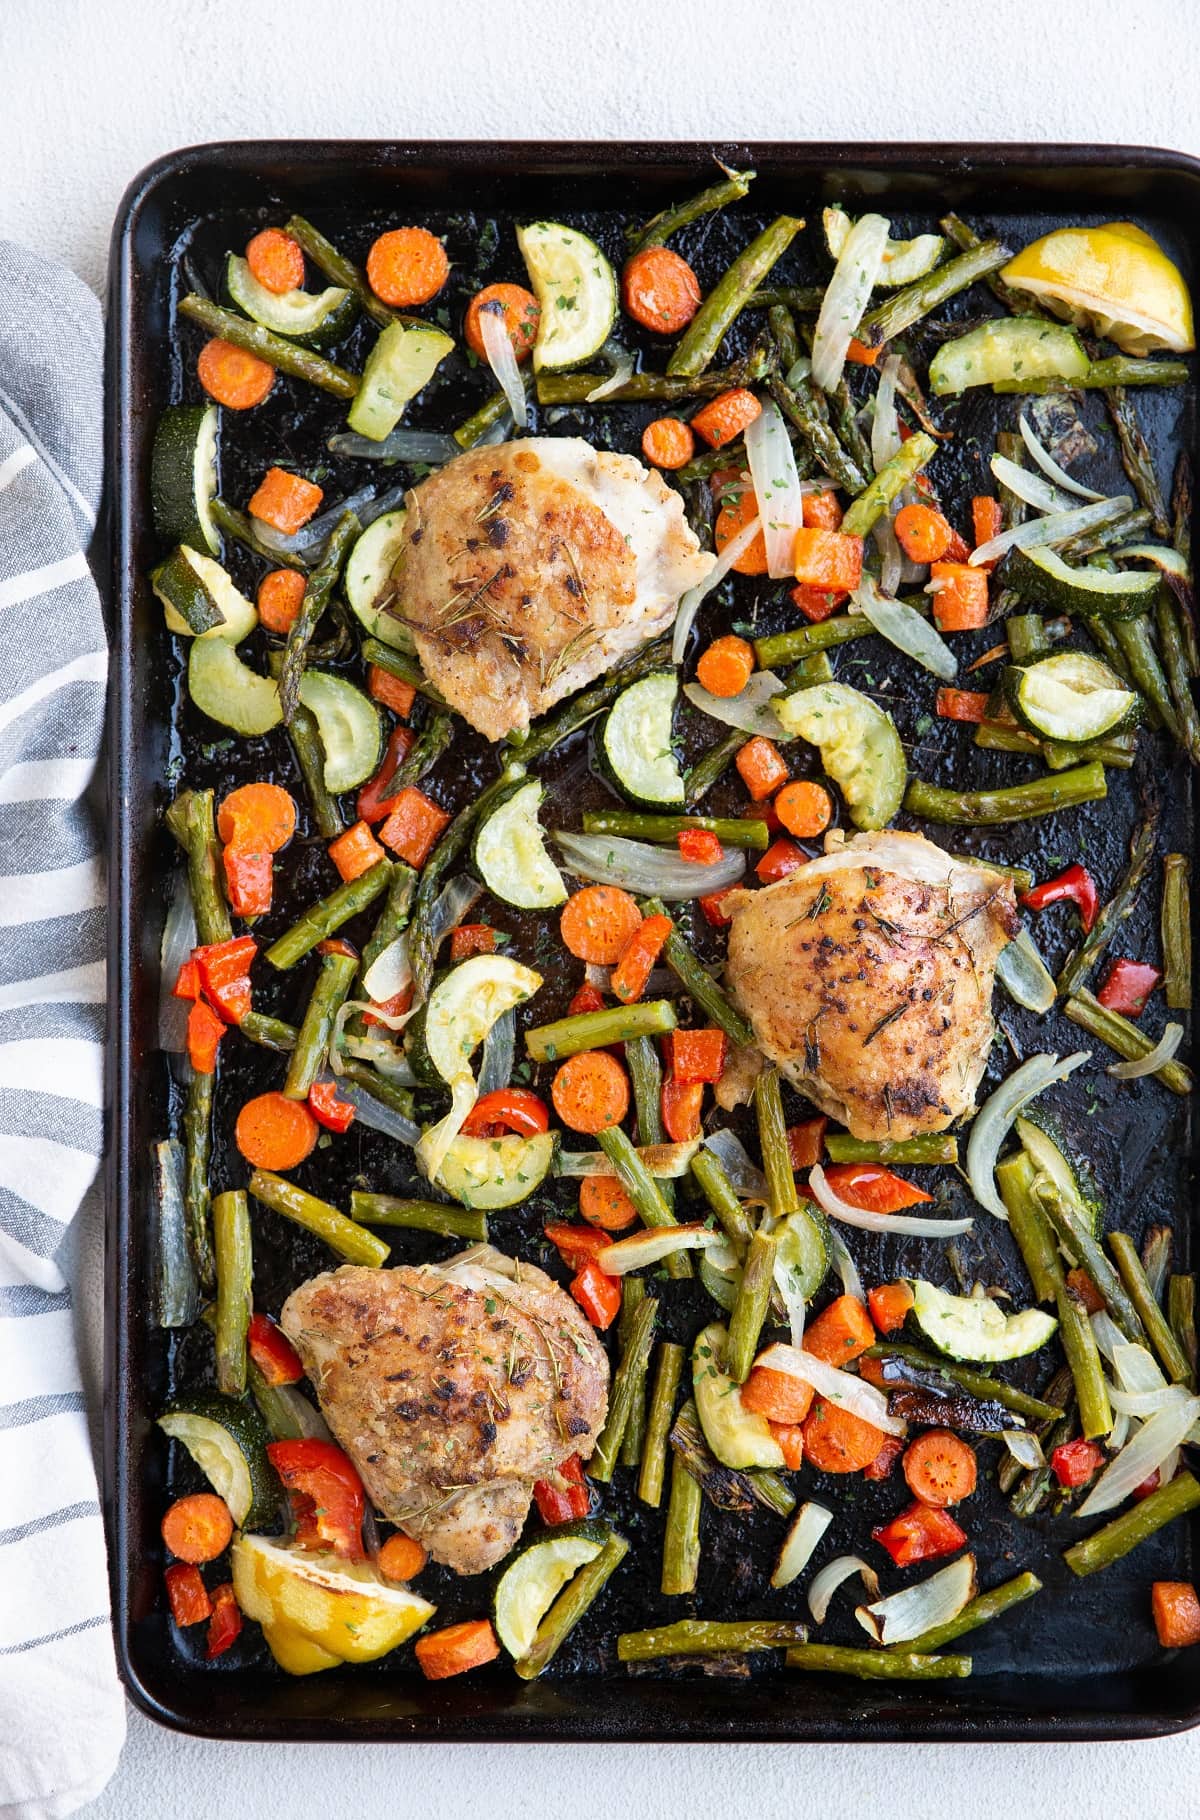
0 240 126 1820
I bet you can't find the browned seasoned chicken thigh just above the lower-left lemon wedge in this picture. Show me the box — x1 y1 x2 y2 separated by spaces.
280 1245 608 1574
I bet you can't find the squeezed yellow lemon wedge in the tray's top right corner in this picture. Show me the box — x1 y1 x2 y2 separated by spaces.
1000 222 1196 355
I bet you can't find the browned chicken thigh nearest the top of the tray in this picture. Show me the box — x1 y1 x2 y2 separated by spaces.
392 437 714 739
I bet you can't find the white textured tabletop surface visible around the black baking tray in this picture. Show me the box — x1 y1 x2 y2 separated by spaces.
0 0 1200 1820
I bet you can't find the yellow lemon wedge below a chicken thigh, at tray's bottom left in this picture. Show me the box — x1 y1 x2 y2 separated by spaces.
233 1536 437 1674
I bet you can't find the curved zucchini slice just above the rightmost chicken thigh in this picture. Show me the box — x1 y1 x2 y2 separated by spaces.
776 683 909 828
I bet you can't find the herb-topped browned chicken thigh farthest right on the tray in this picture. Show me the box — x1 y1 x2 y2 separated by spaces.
727 830 1018 1139
